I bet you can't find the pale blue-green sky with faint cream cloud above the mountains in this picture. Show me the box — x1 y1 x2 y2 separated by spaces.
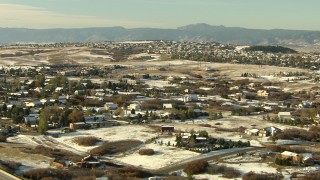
0 0 320 30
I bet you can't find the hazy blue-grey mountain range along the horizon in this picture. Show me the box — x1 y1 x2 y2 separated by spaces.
0 24 320 46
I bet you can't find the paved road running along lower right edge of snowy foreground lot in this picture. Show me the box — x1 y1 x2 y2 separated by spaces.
151 147 265 175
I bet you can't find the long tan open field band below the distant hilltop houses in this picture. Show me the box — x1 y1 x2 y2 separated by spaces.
0 47 317 92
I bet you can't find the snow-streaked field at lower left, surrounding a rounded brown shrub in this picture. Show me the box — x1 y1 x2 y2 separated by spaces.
8 125 157 154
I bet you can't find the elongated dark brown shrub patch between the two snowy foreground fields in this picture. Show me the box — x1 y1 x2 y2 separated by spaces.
91 140 142 156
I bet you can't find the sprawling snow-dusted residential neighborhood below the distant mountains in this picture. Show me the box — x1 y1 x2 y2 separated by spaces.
0 41 320 179
